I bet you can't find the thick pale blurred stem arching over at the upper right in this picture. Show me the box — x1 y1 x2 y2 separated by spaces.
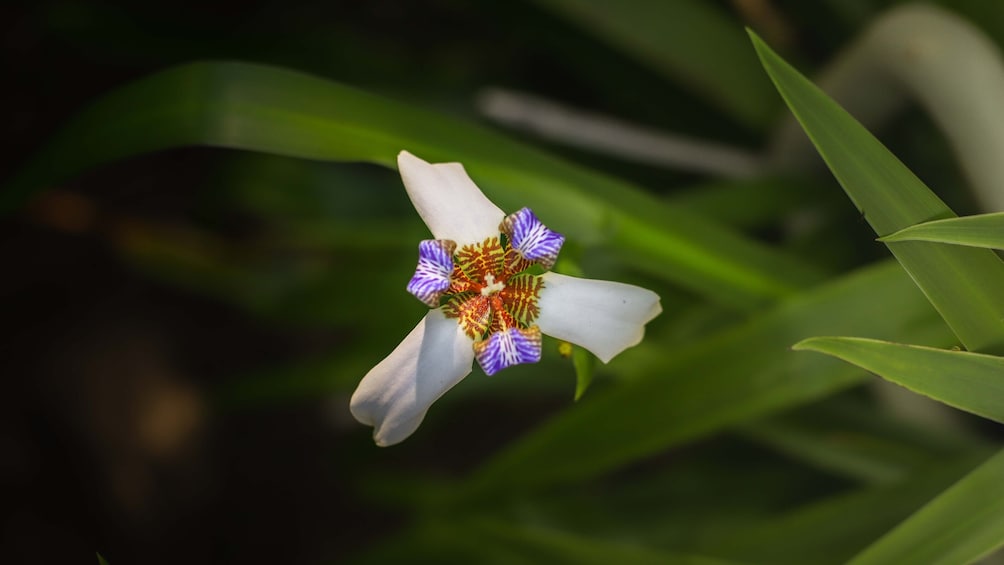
768 4 1004 212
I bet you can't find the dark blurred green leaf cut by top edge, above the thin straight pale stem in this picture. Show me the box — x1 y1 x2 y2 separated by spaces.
538 0 775 126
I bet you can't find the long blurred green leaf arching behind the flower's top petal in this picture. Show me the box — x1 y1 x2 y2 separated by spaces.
9 58 819 309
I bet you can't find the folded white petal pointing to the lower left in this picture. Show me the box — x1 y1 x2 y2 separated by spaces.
349 309 474 446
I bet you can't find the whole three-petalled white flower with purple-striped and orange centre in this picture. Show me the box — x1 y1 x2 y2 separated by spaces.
350 152 662 446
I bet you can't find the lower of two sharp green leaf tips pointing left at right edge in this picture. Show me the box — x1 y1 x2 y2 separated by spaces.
792 337 1004 422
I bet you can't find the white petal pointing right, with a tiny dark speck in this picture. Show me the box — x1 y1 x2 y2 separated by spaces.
535 272 663 363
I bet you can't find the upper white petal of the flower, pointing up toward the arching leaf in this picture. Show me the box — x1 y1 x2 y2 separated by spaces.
398 152 505 246
